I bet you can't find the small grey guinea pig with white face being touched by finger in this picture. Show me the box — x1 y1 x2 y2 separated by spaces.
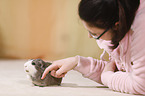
24 59 62 87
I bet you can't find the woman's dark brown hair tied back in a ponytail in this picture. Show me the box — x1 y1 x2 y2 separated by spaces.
78 0 140 49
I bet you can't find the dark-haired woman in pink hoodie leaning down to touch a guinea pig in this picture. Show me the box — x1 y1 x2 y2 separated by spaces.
42 0 145 94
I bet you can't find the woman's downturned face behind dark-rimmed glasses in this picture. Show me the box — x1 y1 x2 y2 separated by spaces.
82 21 112 40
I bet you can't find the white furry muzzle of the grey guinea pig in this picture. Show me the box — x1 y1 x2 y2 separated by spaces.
24 60 37 76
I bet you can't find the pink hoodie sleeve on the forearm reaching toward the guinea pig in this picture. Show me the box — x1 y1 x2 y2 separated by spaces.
74 56 107 84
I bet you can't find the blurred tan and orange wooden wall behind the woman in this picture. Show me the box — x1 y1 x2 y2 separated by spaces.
0 0 105 60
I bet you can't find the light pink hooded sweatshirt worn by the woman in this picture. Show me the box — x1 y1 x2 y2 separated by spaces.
74 0 145 94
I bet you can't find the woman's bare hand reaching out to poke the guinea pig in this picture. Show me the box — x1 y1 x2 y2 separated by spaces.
41 56 78 79
